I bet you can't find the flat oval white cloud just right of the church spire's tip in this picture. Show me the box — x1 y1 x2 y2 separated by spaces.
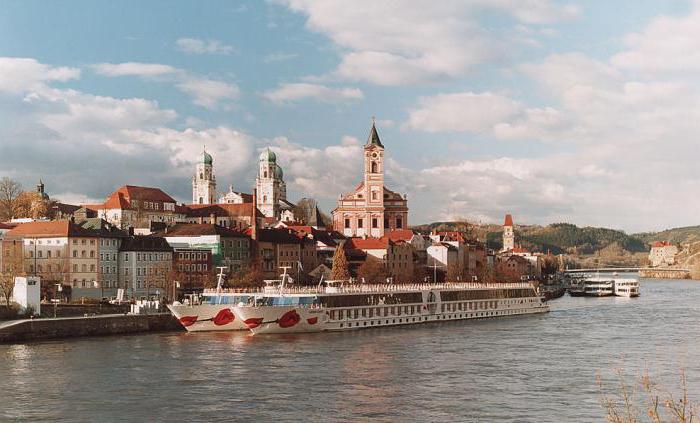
404 92 522 132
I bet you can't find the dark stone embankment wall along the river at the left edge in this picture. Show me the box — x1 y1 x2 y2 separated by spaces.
0 313 183 343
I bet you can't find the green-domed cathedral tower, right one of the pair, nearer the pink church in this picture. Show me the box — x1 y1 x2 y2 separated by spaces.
255 147 287 218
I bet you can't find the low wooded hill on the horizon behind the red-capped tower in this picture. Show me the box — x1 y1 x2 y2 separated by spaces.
415 222 649 254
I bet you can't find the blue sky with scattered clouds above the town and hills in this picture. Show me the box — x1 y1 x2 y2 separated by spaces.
0 0 700 232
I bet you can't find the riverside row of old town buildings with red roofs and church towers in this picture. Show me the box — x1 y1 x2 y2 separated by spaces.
0 123 538 297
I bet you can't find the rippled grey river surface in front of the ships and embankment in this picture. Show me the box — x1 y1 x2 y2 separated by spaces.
0 279 700 422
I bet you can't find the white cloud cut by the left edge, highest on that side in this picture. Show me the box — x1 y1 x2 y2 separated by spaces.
0 57 80 93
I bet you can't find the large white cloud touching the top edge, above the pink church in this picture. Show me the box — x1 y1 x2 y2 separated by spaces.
283 0 578 85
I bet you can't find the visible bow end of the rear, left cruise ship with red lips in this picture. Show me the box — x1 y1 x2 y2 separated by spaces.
168 268 258 332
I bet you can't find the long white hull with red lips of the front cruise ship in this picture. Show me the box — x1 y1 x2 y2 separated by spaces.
231 297 549 334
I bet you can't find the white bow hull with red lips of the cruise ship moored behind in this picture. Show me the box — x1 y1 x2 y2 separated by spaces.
168 304 248 332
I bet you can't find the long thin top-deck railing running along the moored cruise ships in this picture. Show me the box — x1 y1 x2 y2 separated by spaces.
204 282 532 295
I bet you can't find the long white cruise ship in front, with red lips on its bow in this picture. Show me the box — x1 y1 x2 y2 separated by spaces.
232 275 549 334
